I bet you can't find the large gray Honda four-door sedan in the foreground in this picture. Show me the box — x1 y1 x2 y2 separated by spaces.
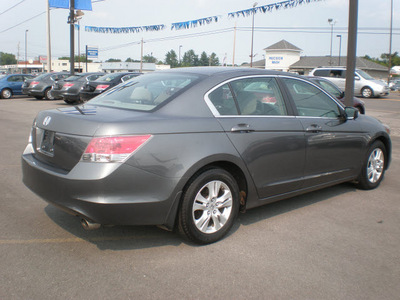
22 67 391 244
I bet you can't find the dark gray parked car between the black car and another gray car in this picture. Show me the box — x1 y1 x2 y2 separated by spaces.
51 72 105 104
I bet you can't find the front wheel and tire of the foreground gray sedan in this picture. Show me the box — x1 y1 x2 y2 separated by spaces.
357 141 387 190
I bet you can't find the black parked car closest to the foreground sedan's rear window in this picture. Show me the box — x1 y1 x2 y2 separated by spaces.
79 72 141 102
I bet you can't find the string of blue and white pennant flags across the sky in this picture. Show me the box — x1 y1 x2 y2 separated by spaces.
85 0 322 34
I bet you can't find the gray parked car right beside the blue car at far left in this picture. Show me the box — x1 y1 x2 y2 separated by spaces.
22 72 70 100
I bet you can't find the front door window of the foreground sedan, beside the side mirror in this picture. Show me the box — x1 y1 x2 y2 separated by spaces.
283 78 340 118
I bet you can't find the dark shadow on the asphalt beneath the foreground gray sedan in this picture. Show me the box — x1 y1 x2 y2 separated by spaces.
45 183 357 251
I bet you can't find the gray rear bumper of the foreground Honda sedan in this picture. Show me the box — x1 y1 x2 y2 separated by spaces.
22 145 179 225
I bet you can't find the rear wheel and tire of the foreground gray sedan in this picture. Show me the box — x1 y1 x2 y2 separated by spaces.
178 168 239 244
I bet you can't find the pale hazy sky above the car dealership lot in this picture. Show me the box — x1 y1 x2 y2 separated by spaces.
0 0 400 64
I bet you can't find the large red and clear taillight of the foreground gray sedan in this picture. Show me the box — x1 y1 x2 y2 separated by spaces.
82 135 151 162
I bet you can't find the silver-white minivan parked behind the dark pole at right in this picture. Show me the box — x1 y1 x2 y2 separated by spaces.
310 67 389 98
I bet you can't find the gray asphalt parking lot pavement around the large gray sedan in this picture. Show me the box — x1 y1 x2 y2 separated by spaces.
0 93 400 299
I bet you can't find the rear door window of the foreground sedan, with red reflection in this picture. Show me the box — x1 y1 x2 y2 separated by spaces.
230 77 287 115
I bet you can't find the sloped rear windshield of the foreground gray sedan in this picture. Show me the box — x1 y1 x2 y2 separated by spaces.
88 72 199 111
